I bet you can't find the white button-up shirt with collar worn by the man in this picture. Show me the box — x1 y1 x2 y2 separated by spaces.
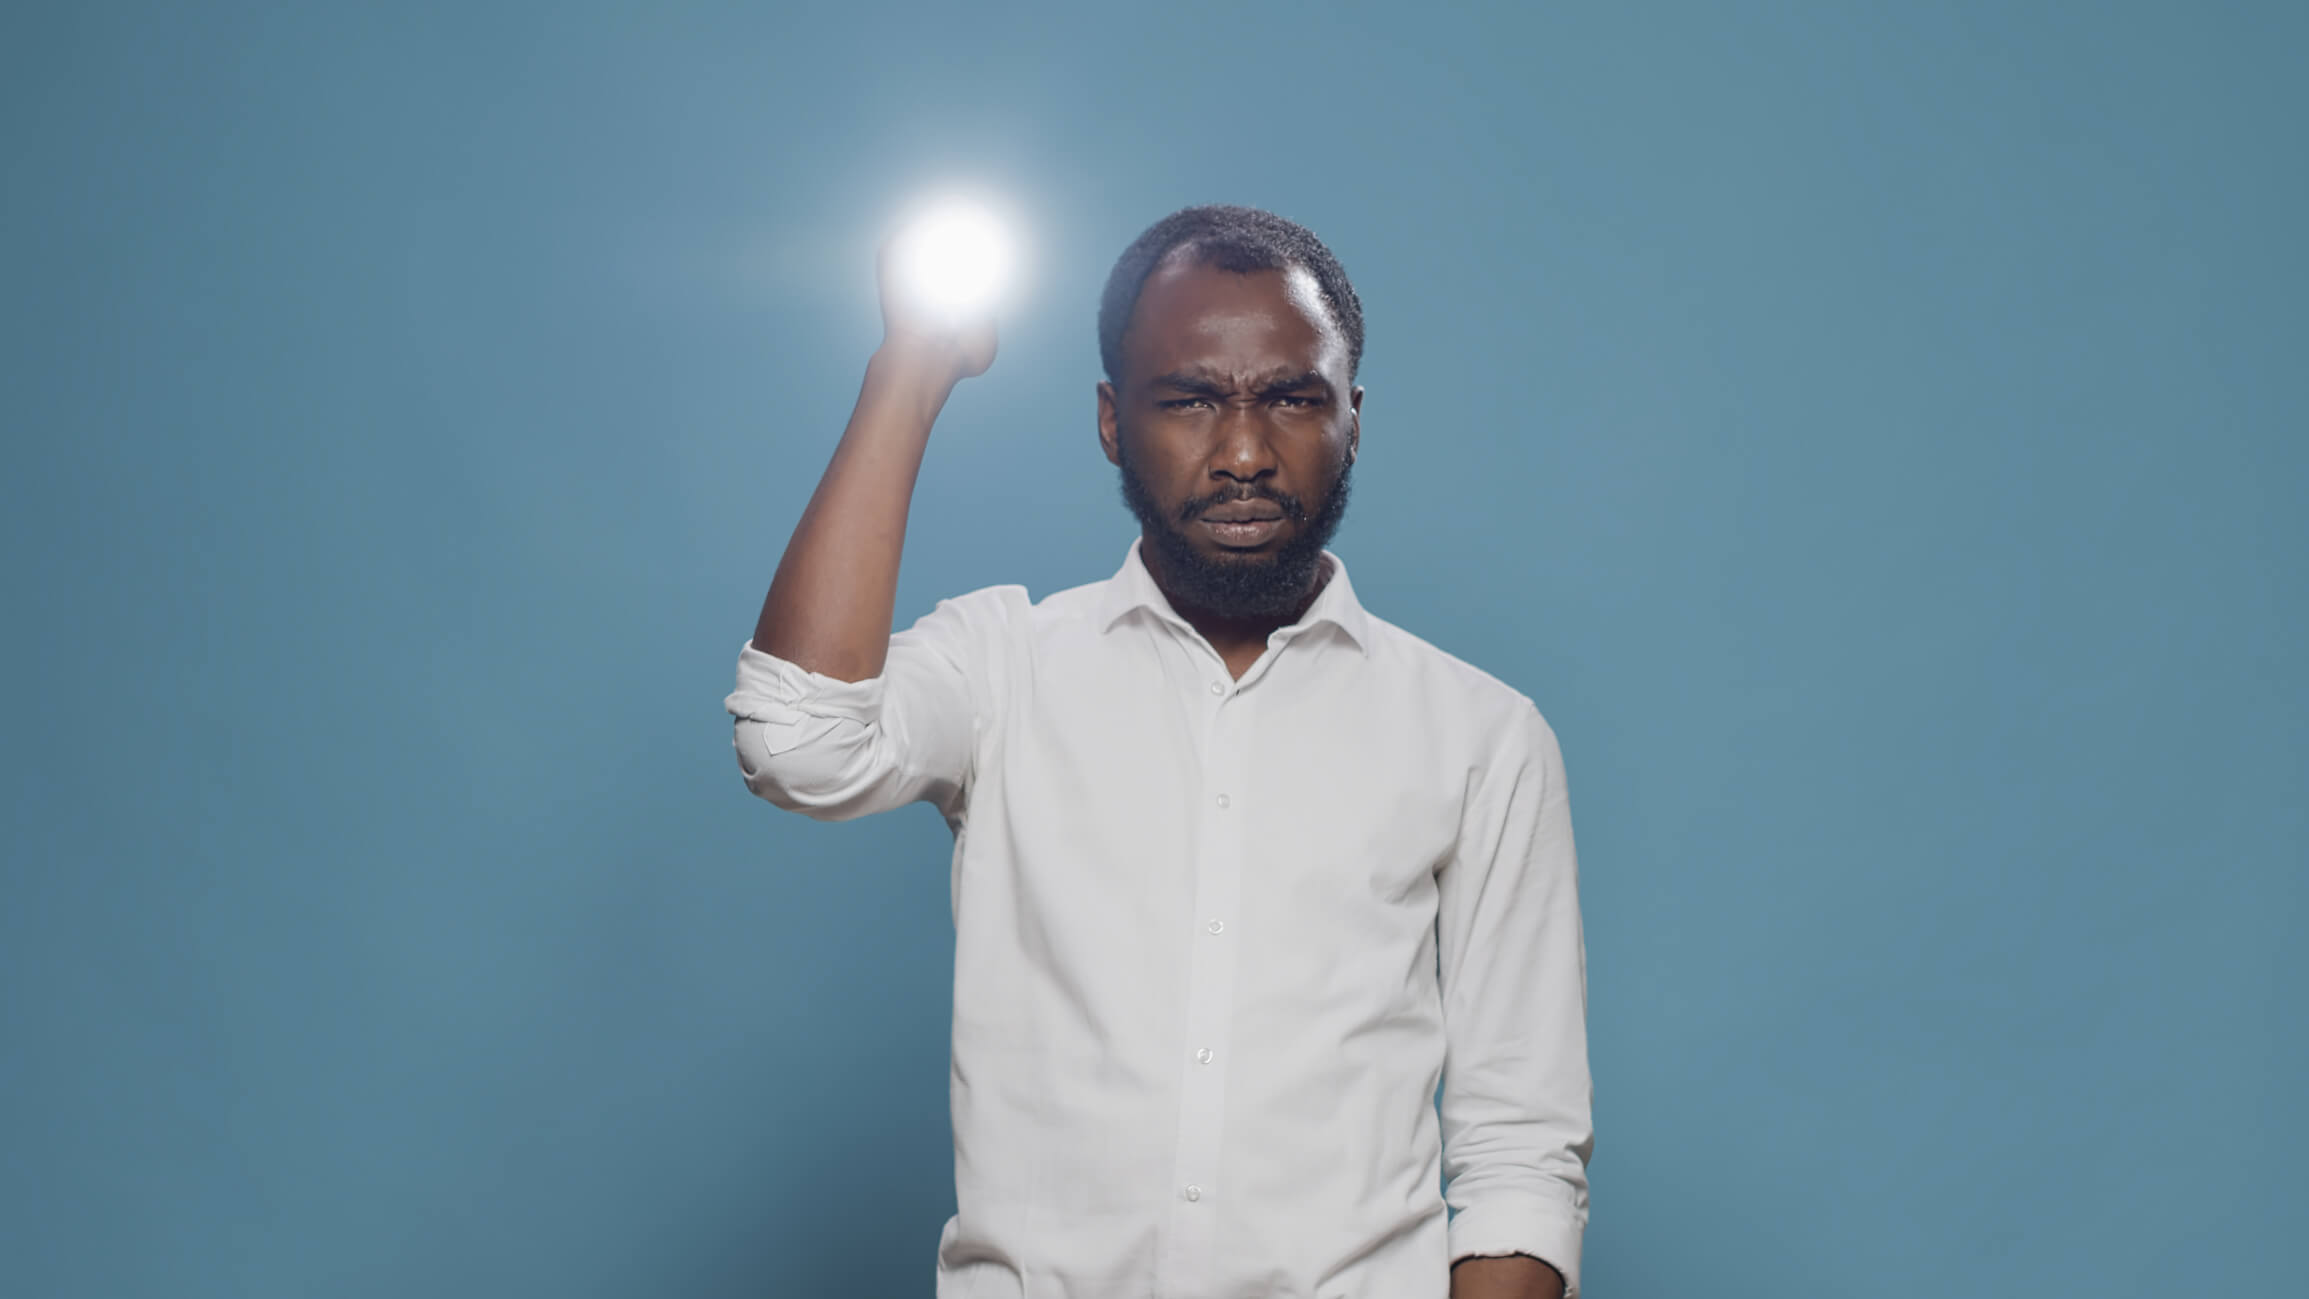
727 540 1593 1299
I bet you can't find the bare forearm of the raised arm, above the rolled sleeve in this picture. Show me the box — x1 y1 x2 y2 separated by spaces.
753 344 956 681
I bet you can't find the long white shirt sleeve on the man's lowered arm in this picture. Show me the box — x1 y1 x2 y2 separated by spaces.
1436 699 1596 1299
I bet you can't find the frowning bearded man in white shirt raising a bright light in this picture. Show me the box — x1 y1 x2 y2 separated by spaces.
727 208 1593 1299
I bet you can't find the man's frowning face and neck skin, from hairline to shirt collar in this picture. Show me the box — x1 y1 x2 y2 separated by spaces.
1099 254 1362 678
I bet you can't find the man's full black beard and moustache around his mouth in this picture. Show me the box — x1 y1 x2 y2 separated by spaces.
1115 427 1355 621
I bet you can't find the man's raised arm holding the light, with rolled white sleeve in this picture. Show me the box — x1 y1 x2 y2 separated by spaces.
725 245 995 819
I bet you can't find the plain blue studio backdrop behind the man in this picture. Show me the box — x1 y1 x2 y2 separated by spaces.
0 2 2309 1299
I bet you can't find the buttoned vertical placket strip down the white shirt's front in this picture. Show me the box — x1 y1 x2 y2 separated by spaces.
1157 662 1251 1299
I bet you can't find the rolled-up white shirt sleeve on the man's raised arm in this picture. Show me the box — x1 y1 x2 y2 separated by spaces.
723 586 1025 821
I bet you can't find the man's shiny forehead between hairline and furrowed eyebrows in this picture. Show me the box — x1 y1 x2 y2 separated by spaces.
1122 254 1346 378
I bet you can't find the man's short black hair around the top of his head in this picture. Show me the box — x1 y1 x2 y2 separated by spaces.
1099 203 1362 383
